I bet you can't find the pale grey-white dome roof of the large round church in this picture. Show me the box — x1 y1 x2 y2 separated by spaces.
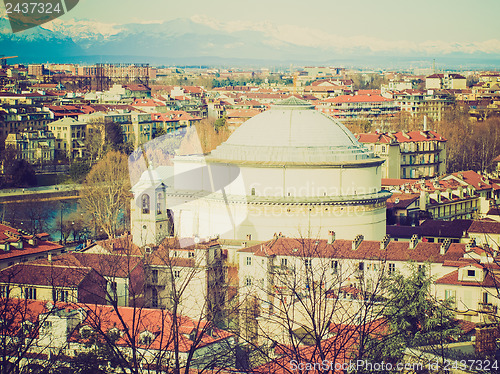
208 96 378 164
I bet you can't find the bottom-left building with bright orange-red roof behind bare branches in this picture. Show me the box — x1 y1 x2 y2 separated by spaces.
0 300 236 373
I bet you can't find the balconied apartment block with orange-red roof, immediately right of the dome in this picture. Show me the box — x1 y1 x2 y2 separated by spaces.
357 130 446 178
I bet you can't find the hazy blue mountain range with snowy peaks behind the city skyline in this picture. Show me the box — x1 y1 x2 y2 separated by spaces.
0 18 500 68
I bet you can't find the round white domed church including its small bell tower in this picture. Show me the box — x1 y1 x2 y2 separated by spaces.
131 97 389 245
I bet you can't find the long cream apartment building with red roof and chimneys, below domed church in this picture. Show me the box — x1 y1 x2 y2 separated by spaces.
239 232 498 334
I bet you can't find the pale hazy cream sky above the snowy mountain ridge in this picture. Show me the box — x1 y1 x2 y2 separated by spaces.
63 0 500 43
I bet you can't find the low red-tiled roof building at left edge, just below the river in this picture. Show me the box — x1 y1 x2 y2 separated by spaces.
0 224 65 269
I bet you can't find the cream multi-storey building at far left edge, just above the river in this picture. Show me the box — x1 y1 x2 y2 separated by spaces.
5 130 56 164
